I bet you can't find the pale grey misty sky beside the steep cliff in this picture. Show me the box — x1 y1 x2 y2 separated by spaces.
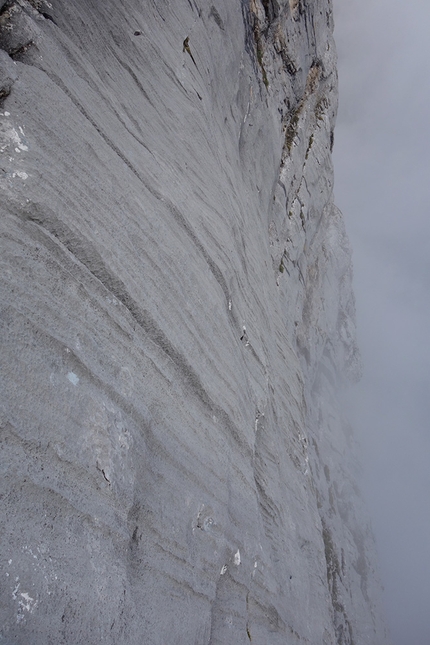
334 0 430 645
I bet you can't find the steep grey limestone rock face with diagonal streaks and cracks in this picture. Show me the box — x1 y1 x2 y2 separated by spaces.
0 0 387 645
